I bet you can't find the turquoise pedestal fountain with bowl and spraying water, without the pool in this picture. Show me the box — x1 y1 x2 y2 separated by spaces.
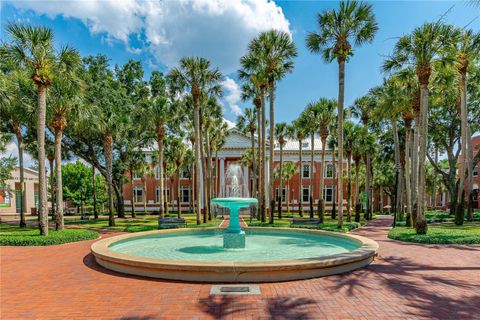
212 164 258 249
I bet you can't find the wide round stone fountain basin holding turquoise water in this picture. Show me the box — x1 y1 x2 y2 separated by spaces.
91 228 378 282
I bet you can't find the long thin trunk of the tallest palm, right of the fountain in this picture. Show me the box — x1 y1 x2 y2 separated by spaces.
337 60 345 228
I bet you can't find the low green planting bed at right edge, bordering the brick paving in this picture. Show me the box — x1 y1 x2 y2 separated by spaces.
388 225 480 244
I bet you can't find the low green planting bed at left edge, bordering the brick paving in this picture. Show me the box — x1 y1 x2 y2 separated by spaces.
0 223 98 246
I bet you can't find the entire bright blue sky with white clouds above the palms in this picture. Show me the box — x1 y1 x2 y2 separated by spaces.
0 0 480 126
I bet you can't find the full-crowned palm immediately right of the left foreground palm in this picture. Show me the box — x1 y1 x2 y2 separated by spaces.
47 55 85 230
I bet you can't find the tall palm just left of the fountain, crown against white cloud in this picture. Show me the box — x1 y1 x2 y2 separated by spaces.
168 57 222 224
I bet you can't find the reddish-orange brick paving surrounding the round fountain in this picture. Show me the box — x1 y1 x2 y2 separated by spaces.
0 217 480 320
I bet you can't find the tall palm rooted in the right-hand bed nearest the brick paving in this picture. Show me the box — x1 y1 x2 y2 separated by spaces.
382 22 452 234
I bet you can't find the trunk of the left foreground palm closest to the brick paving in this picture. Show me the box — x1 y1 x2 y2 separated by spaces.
37 84 48 235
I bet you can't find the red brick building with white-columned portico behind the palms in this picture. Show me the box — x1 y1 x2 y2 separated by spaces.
123 129 353 212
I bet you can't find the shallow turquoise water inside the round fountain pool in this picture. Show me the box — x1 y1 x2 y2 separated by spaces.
110 230 360 262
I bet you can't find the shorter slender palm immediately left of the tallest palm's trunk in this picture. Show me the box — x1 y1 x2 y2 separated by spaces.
318 98 337 223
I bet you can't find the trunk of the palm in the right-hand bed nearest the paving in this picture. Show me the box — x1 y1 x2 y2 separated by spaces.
415 83 428 234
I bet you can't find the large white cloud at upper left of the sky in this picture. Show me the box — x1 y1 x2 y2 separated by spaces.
12 0 290 74
